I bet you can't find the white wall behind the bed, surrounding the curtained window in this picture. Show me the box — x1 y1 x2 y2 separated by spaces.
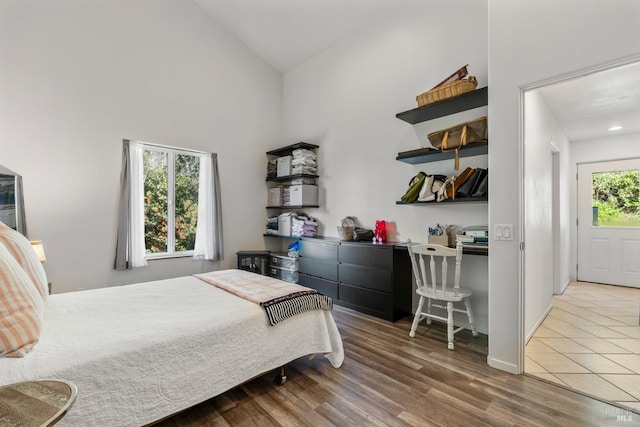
0 0 282 292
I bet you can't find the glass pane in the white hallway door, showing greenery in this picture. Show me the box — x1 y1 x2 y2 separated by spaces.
592 170 640 227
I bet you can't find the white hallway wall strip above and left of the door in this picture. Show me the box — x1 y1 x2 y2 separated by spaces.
569 133 640 280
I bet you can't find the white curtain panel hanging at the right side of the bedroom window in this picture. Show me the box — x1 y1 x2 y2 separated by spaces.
193 153 224 261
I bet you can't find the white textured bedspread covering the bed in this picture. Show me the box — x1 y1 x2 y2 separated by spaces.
0 276 344 426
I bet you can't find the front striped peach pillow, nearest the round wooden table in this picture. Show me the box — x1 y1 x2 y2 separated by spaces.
0 243 45 357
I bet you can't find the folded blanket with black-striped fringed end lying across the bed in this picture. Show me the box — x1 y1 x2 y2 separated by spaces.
194 270 333 325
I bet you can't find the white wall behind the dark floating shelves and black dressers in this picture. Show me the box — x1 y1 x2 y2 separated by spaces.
284 0 488 333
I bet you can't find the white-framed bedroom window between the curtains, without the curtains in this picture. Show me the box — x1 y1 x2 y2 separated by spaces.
143 145 200 258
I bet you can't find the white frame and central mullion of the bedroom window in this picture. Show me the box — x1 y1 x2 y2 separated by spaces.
140 142 209 260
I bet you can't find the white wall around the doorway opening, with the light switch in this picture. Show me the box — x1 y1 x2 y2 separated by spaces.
488 0 640 372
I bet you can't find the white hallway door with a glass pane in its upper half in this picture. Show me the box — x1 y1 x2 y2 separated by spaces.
578 159 640 288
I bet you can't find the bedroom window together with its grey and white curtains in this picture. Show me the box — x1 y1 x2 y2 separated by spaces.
114 140 224 270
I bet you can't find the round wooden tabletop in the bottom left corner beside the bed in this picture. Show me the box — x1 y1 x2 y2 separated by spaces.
0 380 77 427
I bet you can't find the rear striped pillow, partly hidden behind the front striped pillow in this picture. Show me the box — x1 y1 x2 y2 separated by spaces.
0 222 49 301
